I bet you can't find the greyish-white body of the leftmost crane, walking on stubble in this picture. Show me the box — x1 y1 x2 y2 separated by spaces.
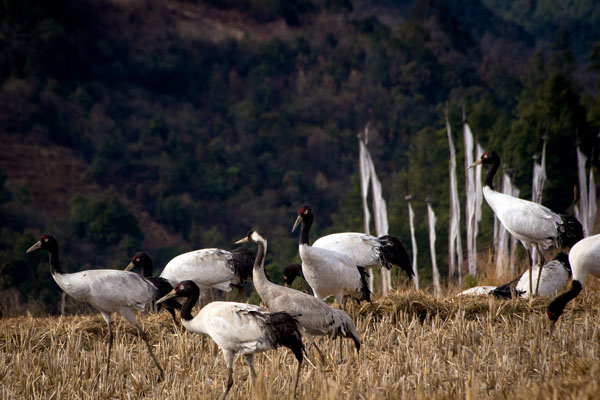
52 269 158 316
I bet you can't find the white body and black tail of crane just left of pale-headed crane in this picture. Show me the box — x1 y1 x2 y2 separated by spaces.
160 248 254 298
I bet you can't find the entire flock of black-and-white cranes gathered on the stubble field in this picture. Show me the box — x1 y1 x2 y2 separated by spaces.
27 151 600 398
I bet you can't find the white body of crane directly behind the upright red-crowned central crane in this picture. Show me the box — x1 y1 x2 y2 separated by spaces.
312 232 382 268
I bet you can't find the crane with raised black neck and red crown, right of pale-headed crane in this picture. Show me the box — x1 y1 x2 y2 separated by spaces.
292 205 371 308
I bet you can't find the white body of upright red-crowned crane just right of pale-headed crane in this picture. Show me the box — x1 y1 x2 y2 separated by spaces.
298 244 361 305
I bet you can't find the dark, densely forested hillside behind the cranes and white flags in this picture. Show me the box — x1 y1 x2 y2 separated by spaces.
0 0 600 312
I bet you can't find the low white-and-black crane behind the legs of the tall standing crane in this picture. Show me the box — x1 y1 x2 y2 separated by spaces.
458 253 571 299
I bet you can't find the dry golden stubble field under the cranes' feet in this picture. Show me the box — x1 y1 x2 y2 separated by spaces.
0 268 600 399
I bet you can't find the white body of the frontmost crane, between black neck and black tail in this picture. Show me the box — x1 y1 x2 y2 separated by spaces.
181 301 284 358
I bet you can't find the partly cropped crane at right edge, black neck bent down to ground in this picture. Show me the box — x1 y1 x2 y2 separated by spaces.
548 234 600 327
